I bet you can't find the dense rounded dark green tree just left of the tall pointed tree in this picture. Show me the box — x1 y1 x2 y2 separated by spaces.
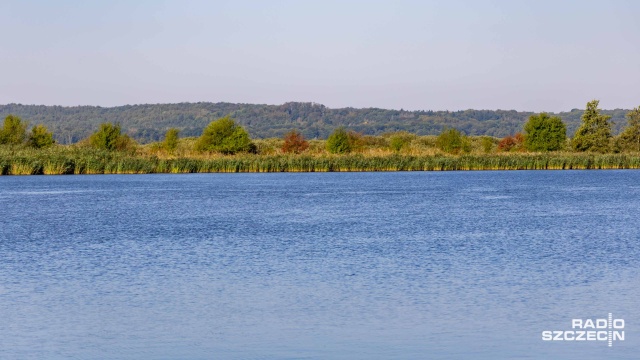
524 113 567 151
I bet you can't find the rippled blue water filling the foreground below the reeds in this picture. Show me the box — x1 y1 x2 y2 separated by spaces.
0 171 640 359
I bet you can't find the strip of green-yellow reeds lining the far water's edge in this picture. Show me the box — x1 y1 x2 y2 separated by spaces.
0 147 640 175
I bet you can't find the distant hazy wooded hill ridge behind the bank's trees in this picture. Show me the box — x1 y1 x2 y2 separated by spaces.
0 102 629 144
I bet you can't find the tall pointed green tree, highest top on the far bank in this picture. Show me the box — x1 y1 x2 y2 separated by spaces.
572 100 611 153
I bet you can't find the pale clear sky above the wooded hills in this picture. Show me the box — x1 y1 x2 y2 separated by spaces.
0 0 640 112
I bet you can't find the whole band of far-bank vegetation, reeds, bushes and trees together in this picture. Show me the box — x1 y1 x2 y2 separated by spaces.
0 100 640 175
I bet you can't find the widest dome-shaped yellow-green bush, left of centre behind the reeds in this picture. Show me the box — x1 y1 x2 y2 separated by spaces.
196 116 255 154
